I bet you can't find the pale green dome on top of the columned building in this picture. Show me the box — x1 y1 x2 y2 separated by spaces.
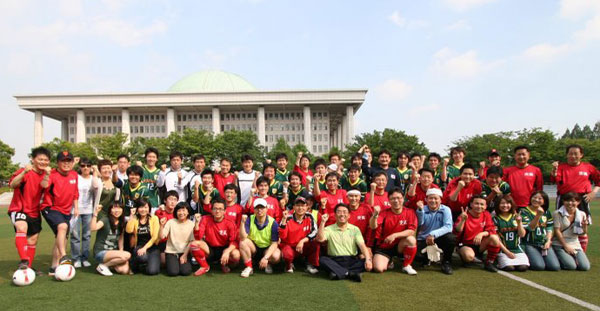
167 70 256 93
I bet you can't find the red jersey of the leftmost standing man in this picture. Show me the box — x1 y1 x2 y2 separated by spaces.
8 168 46 218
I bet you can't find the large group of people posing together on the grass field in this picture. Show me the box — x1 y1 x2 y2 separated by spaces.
8 145 600 281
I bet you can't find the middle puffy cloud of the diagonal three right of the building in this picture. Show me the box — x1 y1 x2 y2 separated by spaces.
431 47 501 78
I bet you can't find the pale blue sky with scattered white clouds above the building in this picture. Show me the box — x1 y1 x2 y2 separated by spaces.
0 0 600 162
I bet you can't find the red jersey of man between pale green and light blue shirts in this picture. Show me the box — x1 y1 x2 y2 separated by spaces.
375 208 418 249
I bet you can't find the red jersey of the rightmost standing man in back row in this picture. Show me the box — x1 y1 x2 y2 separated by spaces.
551 162 600 195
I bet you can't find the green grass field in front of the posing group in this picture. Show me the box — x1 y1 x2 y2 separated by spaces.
0 202 600 311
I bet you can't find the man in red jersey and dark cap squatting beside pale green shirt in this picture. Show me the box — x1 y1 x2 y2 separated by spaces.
279 197 319 274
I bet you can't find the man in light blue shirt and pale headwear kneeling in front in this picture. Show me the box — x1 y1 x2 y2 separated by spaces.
417 188 456 274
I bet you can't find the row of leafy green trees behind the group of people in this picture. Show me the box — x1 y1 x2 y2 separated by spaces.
0 123 600 180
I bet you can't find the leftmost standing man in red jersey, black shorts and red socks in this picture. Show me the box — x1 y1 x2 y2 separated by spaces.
8 147 50 269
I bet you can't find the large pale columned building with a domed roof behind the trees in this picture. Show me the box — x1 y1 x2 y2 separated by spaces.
15 70 367 154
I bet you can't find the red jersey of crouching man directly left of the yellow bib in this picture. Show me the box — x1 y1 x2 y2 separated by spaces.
194 215 238 247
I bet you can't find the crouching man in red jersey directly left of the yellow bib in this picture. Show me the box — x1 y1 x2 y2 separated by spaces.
190 198 240 276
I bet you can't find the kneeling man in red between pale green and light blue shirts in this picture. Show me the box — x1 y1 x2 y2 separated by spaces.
372 188 418 275
